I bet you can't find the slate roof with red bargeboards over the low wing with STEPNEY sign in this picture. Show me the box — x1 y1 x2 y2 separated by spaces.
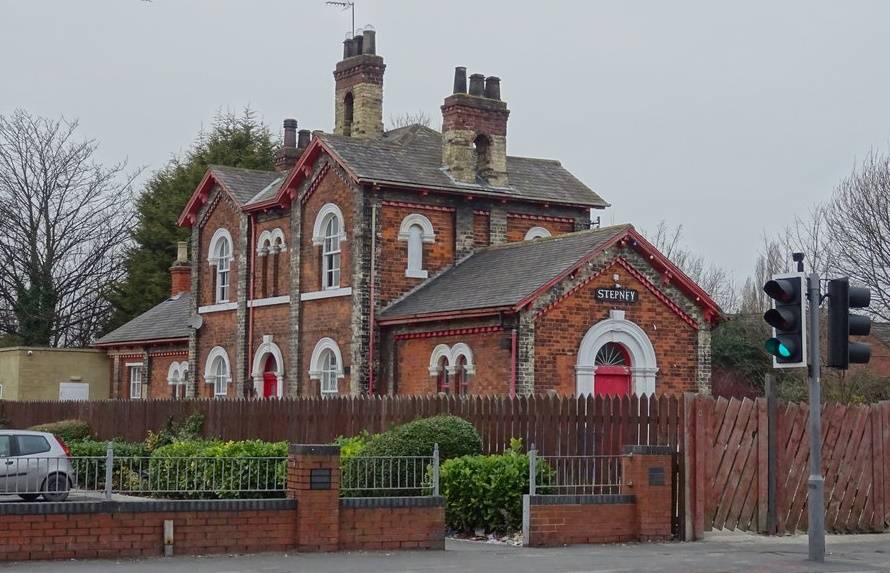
378 225 720 324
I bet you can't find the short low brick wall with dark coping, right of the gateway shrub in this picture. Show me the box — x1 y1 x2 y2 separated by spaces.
523 495 639 547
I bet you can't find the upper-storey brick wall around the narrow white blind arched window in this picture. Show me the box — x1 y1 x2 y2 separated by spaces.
377 202 455 308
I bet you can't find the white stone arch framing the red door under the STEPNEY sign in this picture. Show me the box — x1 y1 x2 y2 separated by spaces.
575 310 658 396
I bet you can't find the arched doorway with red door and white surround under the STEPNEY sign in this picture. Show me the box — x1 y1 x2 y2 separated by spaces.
575 310 658 396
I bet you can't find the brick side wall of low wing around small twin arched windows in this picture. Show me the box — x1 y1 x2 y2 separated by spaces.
394 330 511 394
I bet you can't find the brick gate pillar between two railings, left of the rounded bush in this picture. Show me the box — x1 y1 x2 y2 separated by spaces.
287 444 340 551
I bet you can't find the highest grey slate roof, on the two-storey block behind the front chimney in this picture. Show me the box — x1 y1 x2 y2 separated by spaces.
316 125 609 208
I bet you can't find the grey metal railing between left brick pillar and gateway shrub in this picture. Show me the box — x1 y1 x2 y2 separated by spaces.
340 445 439 497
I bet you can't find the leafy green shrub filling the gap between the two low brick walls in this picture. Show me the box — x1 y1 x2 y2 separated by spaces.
440 440 552 532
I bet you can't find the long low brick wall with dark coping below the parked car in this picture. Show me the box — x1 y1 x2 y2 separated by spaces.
0 499 297 561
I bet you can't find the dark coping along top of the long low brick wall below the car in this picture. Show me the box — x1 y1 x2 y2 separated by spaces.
0 499 297 515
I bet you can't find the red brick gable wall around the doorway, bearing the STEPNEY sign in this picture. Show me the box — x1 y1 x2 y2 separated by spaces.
534 262 698 395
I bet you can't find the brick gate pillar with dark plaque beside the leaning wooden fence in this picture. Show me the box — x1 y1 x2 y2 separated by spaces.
621 446 674 541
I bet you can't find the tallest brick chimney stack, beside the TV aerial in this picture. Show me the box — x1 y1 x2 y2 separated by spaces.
334 26 386 139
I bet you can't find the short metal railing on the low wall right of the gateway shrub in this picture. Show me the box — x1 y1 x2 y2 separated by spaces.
529 449 623 495
